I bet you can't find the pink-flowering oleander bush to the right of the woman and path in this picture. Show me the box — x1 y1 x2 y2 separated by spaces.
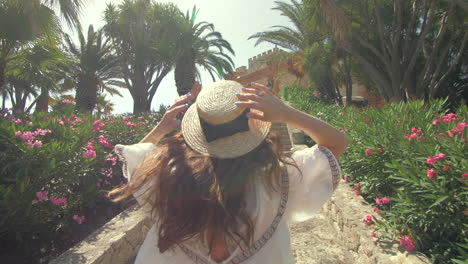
283 86 468 263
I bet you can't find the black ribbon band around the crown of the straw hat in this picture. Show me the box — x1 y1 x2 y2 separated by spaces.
200 108 250 142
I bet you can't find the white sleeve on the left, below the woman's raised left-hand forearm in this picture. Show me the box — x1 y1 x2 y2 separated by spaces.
114 143 155 205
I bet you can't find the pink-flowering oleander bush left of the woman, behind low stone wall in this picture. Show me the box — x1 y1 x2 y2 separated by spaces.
0 105 164 260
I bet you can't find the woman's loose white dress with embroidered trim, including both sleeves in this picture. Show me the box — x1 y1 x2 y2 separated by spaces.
115 143 341 264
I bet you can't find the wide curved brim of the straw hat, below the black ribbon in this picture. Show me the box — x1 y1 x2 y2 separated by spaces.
182 103 271 159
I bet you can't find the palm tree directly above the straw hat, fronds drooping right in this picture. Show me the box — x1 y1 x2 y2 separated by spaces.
174 7 235 95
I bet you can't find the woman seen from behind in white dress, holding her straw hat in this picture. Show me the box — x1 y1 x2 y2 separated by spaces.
111 81 347 264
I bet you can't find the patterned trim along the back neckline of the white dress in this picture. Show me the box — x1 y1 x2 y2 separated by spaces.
179 170 289 264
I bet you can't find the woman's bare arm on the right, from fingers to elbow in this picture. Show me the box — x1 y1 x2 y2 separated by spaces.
236 83 348 159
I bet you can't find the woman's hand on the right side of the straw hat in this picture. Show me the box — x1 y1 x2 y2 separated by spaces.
236 83 292 123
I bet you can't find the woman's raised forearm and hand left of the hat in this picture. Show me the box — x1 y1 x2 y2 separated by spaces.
139 93 192 145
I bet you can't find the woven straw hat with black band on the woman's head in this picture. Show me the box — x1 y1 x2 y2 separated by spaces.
182 81 271 159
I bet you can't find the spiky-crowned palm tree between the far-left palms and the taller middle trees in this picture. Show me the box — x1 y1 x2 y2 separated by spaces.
65 25 123 113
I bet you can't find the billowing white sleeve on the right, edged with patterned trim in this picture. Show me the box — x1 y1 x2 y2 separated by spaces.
285 145 342 222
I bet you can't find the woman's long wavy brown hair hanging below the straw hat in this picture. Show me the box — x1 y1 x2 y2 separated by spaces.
109 133 294 252
